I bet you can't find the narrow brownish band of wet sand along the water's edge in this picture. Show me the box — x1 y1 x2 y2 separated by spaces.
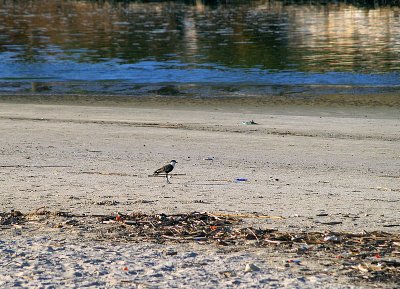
0 93 400 118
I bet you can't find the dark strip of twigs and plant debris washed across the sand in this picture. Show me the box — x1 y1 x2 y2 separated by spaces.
0 210 400 282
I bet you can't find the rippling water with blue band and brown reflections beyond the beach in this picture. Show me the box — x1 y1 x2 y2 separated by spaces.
0 0 400 97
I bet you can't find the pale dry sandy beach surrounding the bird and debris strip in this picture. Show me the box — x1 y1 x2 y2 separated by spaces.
0 98 400 288
